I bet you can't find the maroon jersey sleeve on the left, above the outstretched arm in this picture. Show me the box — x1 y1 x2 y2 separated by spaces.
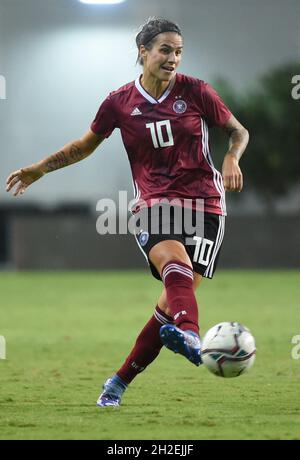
91 96 118 137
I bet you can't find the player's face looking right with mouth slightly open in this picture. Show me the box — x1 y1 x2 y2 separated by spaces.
141 32 182 81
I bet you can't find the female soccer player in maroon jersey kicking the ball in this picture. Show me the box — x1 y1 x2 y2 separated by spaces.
7 19 249 407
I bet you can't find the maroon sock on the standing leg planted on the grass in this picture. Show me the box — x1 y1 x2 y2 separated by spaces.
117 306 172 384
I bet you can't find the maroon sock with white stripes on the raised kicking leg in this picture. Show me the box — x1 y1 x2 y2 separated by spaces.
161 260 199 334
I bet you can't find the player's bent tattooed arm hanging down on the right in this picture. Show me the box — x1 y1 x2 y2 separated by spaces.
222 115 249 192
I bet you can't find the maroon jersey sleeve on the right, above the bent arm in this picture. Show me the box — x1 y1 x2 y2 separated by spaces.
201 82 231 126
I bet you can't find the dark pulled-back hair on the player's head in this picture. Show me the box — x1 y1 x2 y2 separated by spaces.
135 18 182 65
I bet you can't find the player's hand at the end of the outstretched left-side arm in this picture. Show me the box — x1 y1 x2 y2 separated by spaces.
6 164 45 196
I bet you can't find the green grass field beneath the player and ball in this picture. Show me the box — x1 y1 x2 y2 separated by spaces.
0 271 300 440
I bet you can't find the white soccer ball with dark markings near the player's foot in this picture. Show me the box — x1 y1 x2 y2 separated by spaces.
201 322 256 377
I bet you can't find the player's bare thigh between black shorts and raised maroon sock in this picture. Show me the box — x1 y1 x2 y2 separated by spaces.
149 240 192 273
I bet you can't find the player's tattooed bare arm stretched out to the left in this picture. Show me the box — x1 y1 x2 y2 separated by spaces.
6 129 104 196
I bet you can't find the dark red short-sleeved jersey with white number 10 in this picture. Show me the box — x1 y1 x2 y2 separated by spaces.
91 74 231 215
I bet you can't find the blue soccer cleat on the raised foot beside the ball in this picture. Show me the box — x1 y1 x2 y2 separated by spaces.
159 324 202 366
